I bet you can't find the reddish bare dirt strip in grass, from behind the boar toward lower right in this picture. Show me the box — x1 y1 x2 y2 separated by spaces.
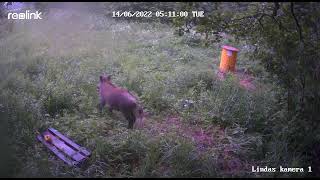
141 116 251 175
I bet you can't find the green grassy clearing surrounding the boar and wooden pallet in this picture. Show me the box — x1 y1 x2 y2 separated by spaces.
0 5 290 177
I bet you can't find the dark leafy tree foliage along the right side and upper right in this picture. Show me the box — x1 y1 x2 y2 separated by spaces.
176 2 320 176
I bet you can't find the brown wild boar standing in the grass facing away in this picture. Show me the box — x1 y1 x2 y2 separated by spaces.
97 75 144 129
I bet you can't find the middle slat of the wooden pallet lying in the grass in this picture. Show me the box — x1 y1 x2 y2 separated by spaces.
43 131 86 162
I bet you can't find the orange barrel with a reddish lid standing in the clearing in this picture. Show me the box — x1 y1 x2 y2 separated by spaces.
220 46 239 72
